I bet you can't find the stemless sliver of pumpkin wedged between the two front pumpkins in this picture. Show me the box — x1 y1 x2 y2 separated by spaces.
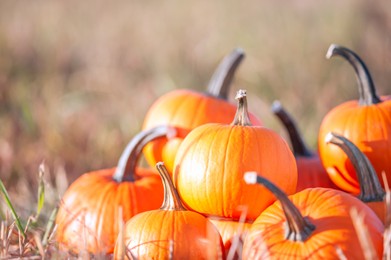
209 218 251 259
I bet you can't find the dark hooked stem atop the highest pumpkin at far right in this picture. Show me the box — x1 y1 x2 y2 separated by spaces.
326 44 381 106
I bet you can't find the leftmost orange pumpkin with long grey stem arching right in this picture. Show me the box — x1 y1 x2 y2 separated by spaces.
56 126 175 254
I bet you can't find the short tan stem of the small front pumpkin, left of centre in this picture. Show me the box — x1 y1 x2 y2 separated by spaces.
156 162 186 210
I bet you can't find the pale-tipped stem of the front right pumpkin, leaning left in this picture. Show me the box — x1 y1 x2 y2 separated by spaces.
244 172 316 242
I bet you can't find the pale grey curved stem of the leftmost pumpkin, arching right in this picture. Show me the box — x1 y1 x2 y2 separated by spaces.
113 126 176 182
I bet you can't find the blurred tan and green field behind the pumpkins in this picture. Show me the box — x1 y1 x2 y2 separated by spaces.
0 0 391 207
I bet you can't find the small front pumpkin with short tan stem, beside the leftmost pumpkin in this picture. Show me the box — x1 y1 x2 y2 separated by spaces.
114 163 224 259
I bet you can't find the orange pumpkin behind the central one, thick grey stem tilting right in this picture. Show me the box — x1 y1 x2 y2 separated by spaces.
143 49 261 173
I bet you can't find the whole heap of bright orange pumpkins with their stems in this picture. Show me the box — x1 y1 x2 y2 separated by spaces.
56 44 391 259
